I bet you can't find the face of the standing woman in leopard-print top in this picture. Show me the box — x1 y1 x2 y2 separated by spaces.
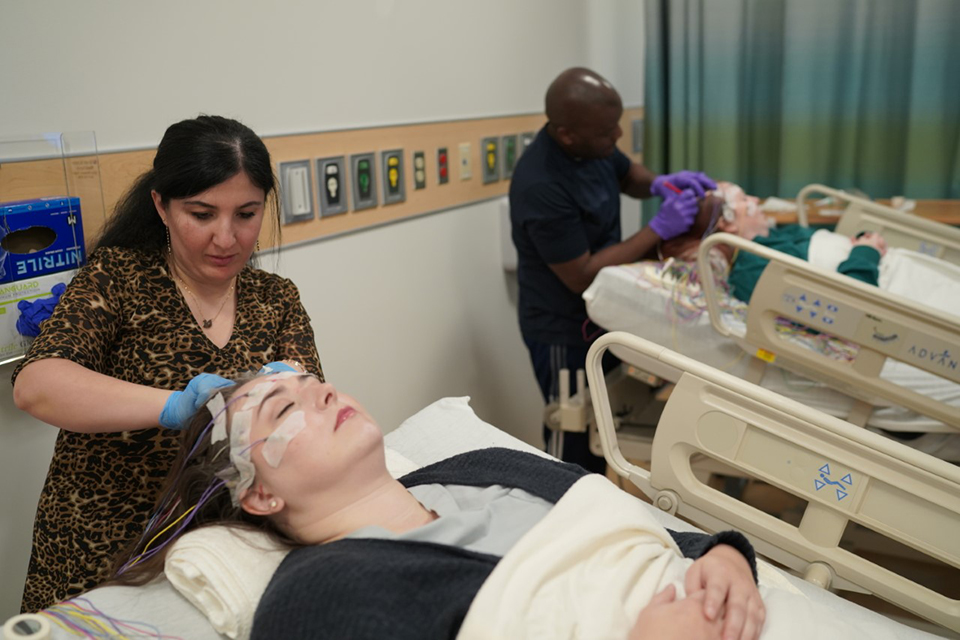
152 172 266 284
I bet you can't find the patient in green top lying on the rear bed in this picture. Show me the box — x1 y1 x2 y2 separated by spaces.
661 182 887 302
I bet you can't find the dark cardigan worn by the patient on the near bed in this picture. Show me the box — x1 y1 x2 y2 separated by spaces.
252 449 756 640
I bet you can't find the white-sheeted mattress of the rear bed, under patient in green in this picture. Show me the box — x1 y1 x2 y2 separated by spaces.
583 262 960 460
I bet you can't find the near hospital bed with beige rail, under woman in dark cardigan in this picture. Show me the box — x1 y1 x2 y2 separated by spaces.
3 388 960 640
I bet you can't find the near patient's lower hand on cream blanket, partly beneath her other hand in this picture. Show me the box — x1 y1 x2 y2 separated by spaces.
628 585 723 640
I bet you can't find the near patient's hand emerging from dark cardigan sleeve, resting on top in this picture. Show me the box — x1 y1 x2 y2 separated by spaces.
684 544 766 640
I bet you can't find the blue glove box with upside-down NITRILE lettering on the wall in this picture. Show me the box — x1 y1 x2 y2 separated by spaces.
0 196 86 283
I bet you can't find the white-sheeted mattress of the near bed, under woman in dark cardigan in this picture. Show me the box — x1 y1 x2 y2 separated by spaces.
20 398 935 640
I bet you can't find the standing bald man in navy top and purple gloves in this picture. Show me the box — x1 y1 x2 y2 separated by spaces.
510 68 716 472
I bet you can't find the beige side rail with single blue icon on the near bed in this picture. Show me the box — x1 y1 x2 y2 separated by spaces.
587 332 960 630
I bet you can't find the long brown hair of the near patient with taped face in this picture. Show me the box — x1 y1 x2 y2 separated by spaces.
110 377 301 585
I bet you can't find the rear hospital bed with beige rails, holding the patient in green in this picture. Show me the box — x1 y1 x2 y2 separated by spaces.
584 185 960 459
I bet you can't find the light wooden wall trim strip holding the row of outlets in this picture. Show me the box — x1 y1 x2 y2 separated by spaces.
0 107 643 249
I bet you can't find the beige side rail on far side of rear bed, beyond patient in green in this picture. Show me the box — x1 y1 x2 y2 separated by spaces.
797 184 960 264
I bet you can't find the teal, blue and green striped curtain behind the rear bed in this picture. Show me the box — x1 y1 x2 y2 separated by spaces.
644 0 960 224
